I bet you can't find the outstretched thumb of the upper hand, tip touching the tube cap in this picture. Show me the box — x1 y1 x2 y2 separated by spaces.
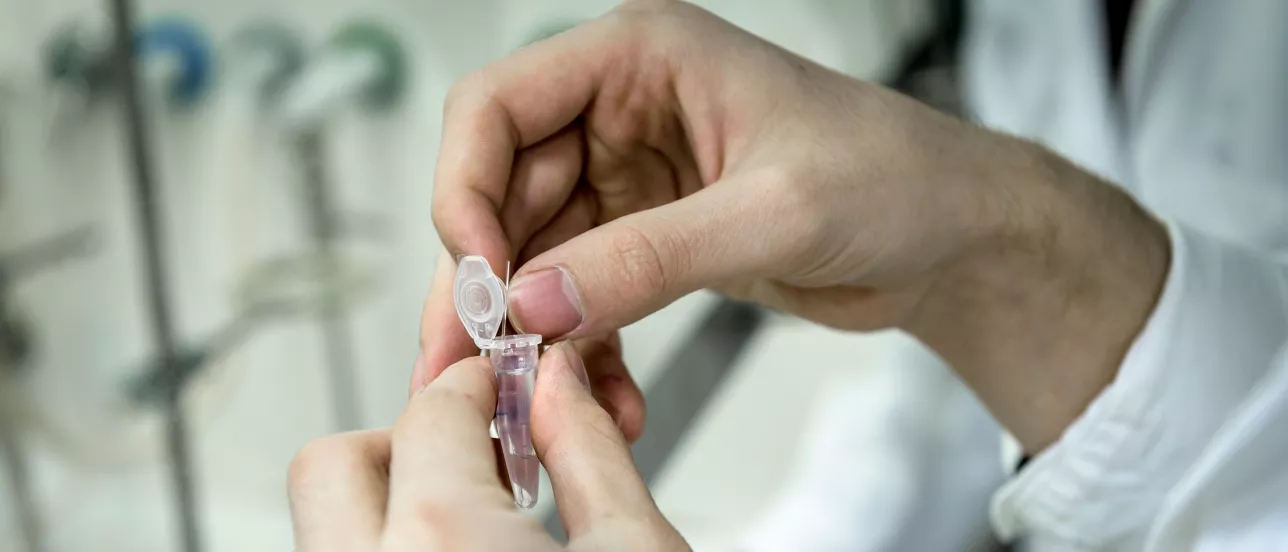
509 171 808 340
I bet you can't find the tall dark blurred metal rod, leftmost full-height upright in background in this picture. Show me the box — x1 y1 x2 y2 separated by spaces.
108 0 201 552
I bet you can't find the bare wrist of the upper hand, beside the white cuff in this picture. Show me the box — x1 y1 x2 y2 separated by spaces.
905 136 1170 453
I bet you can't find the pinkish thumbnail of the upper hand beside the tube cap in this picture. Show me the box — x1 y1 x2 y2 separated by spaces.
509 266 585 338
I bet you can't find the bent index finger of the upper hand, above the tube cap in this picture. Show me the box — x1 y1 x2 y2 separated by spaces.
433 24 622 294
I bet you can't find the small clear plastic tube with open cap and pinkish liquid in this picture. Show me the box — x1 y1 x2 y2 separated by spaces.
453 256 541 510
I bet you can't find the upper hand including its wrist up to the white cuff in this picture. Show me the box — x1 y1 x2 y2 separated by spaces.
413 0 1168 452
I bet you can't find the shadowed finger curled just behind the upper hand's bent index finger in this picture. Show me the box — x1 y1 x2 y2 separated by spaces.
501 126 585 254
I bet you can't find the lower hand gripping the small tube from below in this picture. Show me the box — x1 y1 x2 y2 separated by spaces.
289 345 688 552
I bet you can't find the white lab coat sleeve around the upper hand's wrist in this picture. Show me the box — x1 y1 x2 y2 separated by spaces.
992 224 1288 549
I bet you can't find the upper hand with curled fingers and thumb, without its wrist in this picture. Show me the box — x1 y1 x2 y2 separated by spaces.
422 1 1001 362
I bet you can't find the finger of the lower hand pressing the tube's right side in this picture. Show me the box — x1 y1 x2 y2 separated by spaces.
532 344 665 543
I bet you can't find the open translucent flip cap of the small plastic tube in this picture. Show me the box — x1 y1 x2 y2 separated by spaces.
452 255 506 349
